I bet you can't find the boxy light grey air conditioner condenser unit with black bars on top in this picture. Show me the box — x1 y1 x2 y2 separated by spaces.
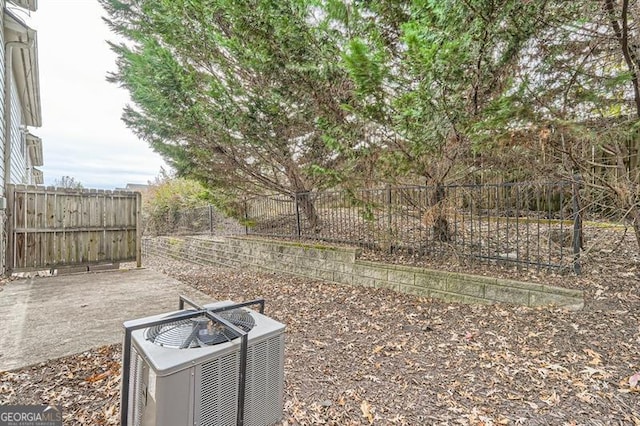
122 298 285 426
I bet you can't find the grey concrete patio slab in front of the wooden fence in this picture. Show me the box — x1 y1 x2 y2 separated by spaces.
0 269 211 371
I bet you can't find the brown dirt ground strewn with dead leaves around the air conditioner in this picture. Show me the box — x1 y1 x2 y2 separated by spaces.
0 250 640 425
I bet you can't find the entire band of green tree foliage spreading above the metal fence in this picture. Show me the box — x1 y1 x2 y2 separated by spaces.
100 0 640 223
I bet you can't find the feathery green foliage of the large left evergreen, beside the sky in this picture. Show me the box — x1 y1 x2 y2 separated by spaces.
101 0 358 204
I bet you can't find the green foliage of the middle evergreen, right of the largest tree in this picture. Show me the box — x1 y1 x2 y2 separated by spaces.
327 0 547 183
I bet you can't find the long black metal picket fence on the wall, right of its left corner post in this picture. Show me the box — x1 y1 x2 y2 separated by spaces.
245 182 582 272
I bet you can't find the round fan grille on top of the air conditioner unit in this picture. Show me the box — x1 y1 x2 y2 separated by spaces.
145 309 255 349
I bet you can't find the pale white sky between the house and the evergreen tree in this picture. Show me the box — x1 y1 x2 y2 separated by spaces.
23 0 169 189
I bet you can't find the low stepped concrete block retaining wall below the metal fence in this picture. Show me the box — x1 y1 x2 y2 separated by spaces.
143 237 584 309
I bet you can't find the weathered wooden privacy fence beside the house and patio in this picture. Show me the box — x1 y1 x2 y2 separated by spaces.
6 185 141 272
